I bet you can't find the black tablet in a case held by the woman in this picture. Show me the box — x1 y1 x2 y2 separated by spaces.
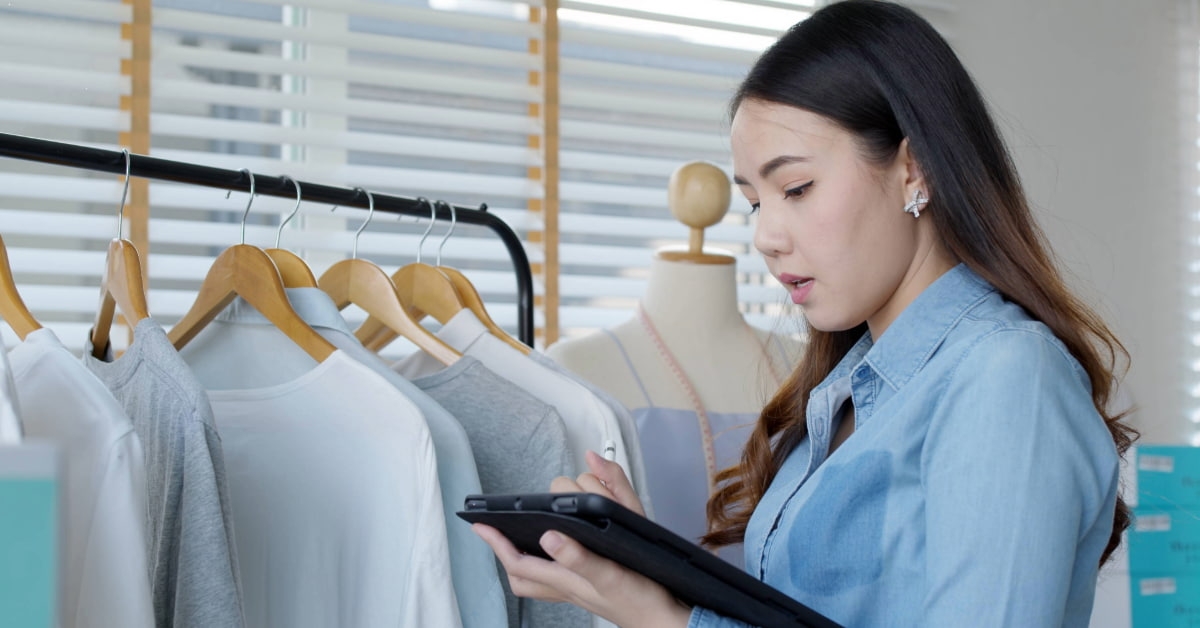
458 492 839 628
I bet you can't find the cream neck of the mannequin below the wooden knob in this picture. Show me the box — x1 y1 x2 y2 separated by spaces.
642 257 745 337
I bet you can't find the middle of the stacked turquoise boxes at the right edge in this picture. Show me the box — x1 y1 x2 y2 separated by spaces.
1127 508 1200 576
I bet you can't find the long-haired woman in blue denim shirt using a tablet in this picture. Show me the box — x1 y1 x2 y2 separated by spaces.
476 0 1133 628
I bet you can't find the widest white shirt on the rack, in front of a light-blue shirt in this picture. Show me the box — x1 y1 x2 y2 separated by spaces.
181 307 461 628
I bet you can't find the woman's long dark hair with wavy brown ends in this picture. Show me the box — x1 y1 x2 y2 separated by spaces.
703 0 1136 563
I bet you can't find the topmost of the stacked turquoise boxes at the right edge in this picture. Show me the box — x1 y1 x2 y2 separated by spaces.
1136 445 1200 513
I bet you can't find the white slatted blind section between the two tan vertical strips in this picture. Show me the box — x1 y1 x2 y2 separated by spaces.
151 0 541 353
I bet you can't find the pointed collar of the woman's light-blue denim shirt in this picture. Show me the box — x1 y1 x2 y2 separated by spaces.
806 264 995 456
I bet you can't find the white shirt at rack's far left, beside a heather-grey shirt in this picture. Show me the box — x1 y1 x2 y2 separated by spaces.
10 328 154 628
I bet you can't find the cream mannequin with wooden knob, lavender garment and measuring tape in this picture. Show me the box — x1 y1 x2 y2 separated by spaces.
546 162 799 562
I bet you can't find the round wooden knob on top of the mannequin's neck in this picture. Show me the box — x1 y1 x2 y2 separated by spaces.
659 161 733 264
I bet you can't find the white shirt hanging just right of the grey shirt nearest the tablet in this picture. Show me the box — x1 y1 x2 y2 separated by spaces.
392 309 630 482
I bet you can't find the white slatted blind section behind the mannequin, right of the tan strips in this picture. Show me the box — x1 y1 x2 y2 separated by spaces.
558 0 812 336
